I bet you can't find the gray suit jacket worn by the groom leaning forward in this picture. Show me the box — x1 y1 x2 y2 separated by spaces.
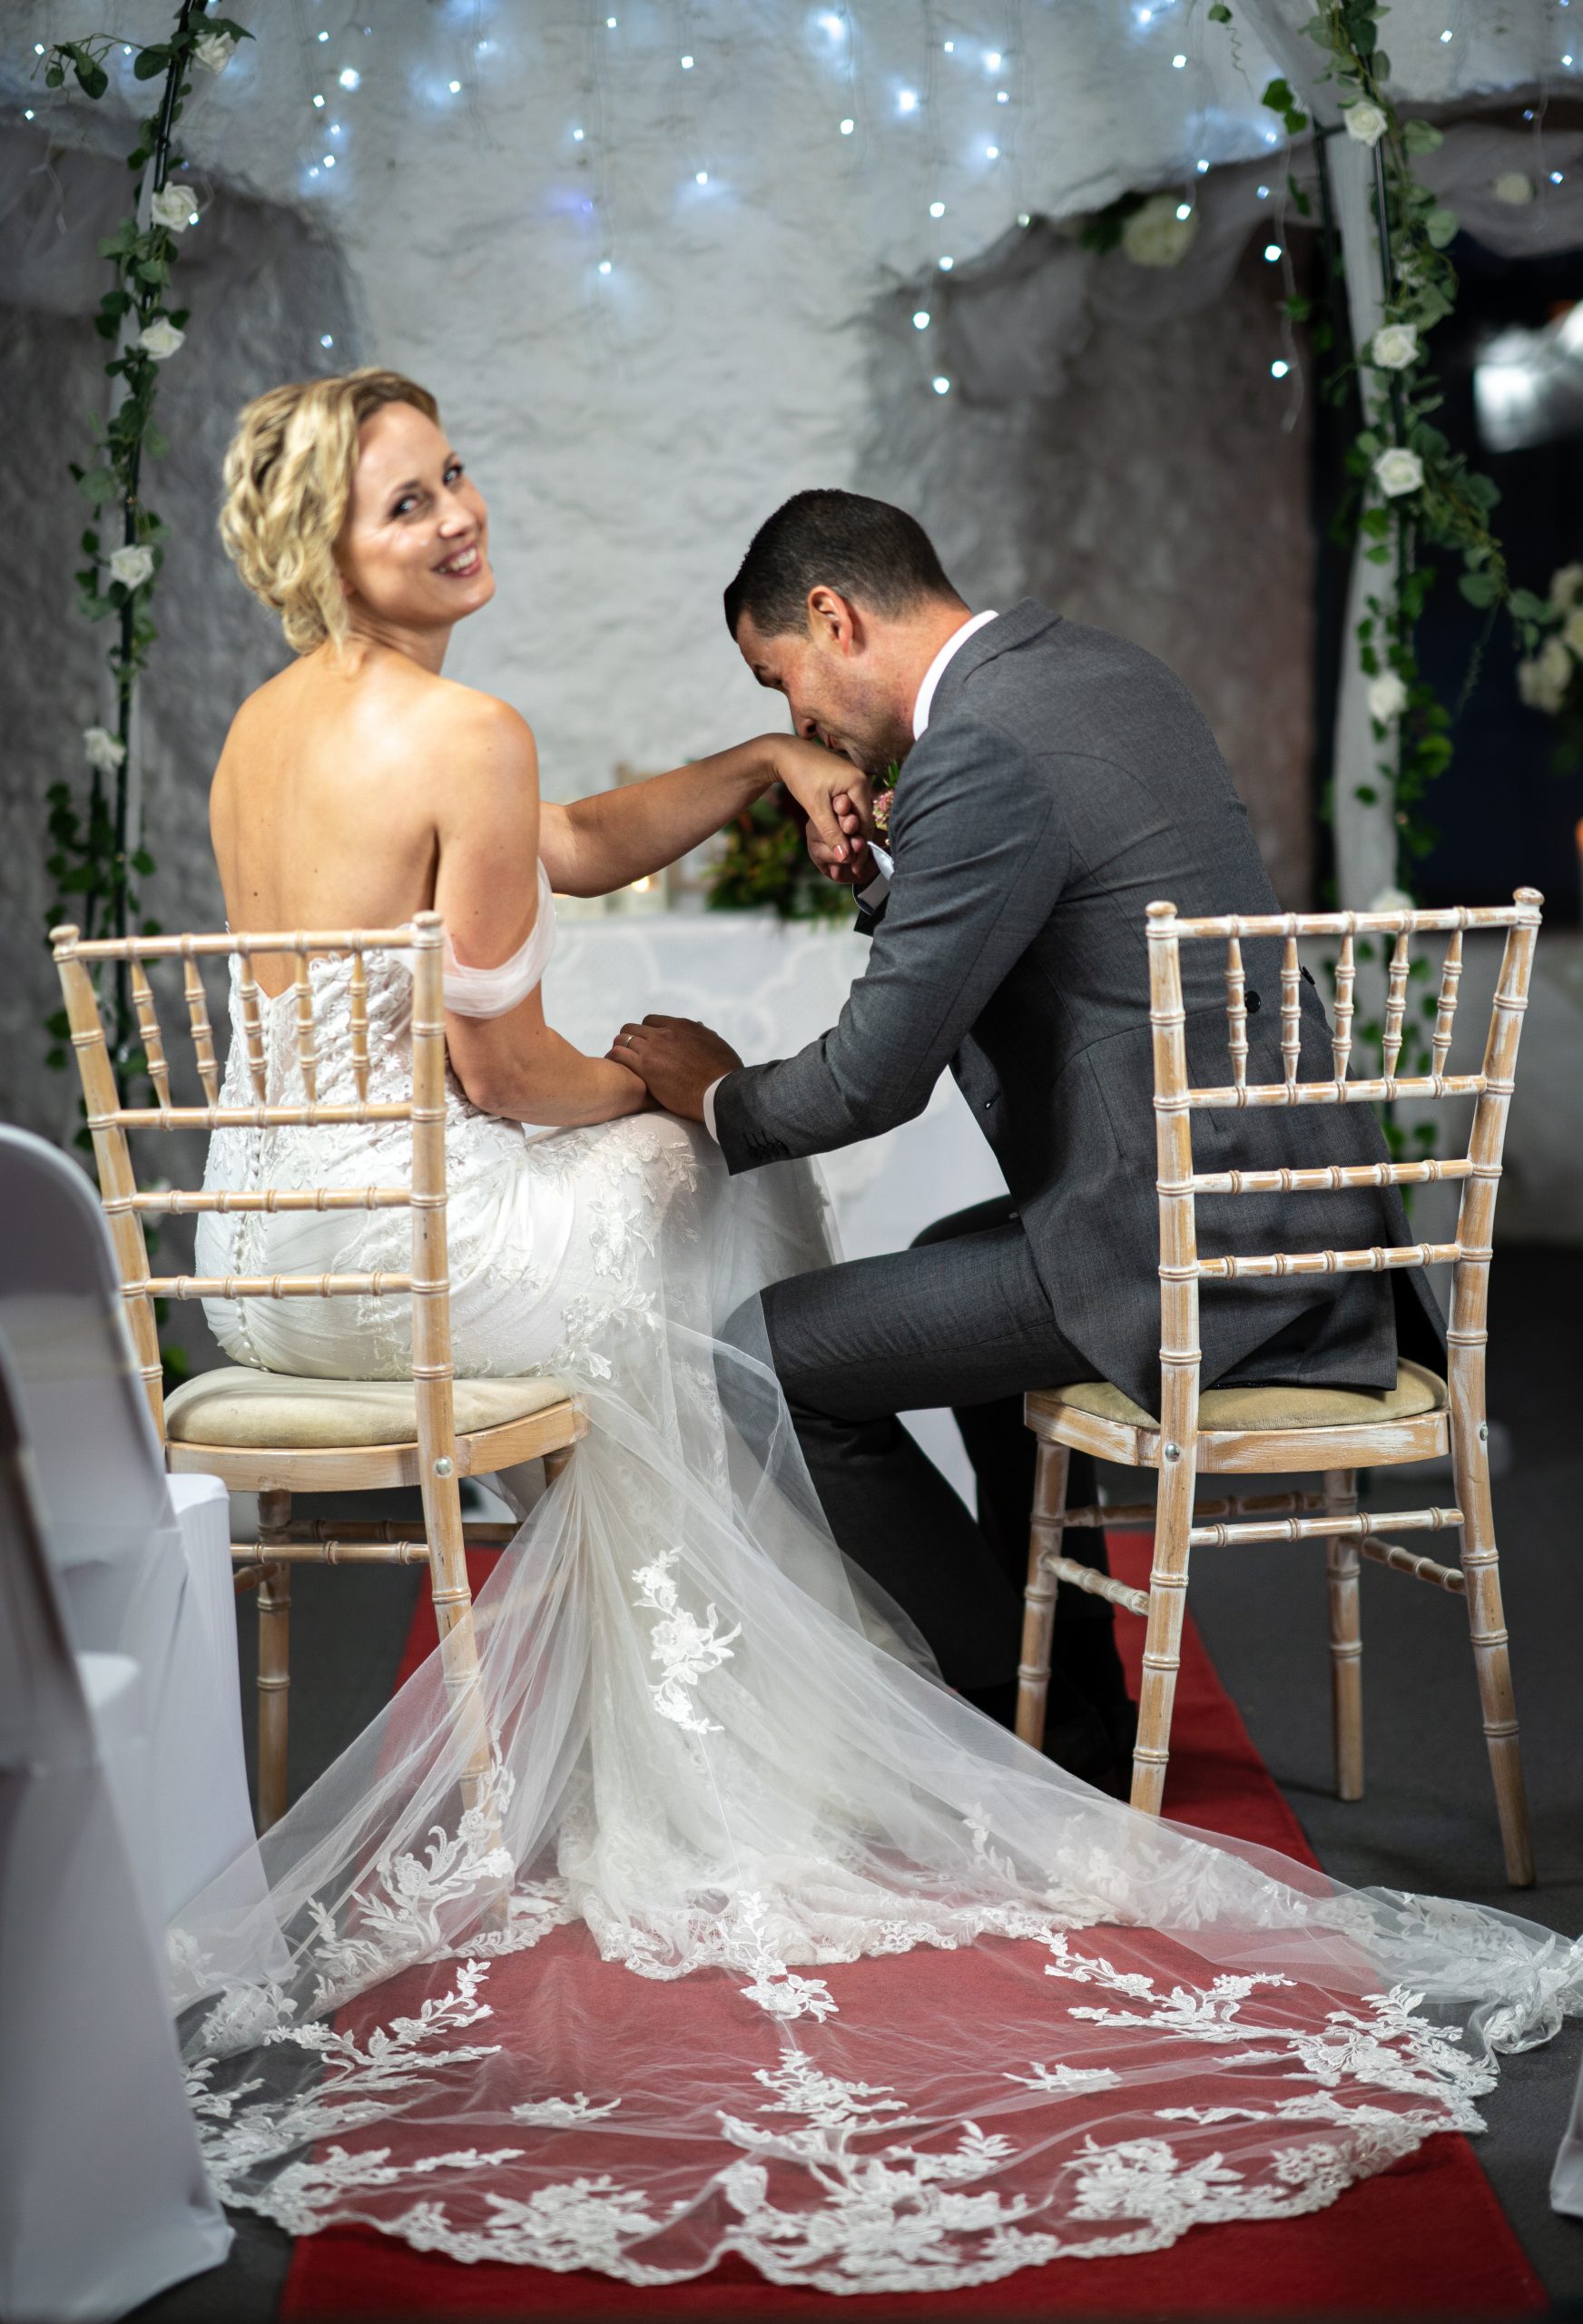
716 599 1411 1411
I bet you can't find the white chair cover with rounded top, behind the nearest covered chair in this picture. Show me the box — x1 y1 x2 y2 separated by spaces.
0 1128 253 1922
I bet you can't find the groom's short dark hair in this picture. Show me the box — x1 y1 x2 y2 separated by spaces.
725 493 958 636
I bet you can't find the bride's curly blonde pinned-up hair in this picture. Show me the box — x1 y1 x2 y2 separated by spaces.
221 362 439 653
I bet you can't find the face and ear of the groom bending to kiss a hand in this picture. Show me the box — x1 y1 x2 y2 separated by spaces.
737 590 911 781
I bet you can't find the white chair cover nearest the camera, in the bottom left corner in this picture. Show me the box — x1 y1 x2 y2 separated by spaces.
0 1353 231 2324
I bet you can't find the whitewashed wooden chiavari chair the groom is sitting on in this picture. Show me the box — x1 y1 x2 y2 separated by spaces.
1018 888 1543 1887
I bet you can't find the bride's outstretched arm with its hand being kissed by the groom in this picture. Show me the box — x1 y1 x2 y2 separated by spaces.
539 734 867 895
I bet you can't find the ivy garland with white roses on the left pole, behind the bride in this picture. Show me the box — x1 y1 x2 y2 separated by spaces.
44 0 253 1088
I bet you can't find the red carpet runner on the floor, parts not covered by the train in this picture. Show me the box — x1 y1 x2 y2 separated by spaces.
281 1534 1549 2324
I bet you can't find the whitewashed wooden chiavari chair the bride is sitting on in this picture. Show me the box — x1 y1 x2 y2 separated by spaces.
51 911 588 1829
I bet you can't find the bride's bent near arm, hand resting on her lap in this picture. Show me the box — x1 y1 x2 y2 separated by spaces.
435 694 649 1128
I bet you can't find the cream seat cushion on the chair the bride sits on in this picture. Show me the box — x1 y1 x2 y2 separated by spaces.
165 1364 572 1450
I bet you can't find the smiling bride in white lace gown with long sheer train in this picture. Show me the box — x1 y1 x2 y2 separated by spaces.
170 372 1583 2291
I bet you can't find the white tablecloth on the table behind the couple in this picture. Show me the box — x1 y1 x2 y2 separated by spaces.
544 911 1004 1260
